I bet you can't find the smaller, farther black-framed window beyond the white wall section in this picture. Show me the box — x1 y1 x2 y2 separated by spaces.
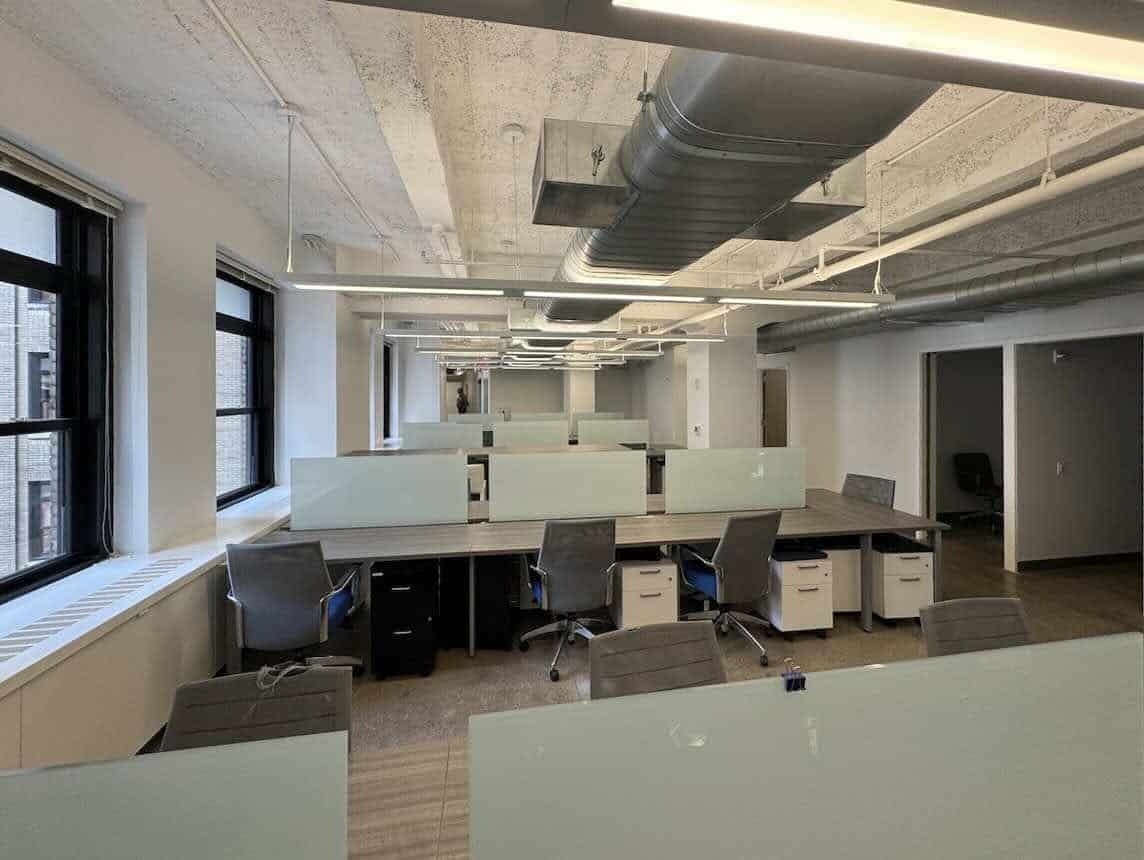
215 272 275 508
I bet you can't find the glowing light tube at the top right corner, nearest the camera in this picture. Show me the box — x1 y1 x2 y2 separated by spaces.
612 0 1144 83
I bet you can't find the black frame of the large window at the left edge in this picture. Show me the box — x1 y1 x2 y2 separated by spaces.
0 172 113 603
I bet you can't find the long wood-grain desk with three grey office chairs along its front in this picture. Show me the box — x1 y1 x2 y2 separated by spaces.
263 489 948 654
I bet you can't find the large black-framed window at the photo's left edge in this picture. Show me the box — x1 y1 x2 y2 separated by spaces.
0 173 111 600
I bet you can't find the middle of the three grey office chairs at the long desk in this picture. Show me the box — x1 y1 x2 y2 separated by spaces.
519 519 615 680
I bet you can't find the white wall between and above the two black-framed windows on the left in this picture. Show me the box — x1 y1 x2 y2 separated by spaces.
0 23 283 551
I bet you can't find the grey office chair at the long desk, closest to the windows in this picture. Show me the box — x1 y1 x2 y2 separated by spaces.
227 541 360 672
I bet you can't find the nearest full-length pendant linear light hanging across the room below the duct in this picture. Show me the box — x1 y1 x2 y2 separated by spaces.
279 272 893 311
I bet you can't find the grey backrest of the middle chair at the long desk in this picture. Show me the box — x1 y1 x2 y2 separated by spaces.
537 519 615 613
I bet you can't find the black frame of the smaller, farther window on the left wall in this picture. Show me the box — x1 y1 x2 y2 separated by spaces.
215 268 275 510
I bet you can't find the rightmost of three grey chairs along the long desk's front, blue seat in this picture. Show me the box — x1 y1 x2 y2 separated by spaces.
681 511 782 666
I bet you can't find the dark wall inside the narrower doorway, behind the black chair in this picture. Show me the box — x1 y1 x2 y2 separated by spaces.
934 349 1004 513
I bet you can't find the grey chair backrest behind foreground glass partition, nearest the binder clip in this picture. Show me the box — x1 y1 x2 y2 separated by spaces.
588 621 726 699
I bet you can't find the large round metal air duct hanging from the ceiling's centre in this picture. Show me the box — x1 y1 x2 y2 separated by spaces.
533 48 938 323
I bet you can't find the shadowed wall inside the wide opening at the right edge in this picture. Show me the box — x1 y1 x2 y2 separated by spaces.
1017 336 1144 562
